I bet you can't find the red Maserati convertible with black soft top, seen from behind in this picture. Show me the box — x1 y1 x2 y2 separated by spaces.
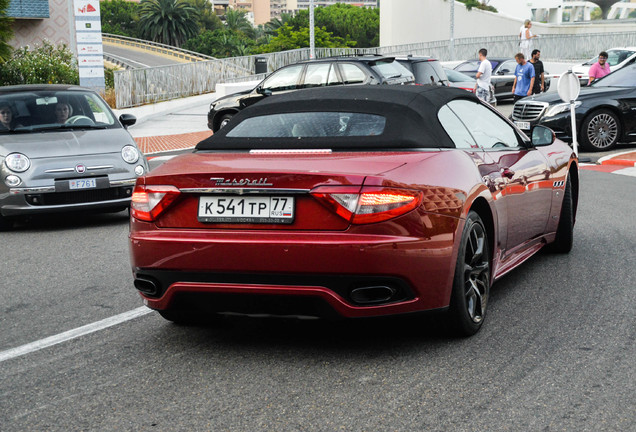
130 86 579 335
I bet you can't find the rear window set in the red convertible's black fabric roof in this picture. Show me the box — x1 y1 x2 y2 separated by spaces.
226 112 386 138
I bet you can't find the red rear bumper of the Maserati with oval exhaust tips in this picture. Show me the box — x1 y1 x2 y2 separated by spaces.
130 220 459 317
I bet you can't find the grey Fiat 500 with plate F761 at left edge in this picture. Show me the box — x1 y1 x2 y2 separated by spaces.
0 85 148 230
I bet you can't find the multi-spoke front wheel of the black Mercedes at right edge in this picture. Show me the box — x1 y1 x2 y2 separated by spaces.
581 109 621 151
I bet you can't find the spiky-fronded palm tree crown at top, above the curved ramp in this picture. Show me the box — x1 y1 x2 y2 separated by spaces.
139 0 199 46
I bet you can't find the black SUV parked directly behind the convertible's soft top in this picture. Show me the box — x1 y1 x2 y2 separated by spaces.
208 55 414 132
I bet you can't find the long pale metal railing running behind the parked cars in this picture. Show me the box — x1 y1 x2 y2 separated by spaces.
114 31 636 108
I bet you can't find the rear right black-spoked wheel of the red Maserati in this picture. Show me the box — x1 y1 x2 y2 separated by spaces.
448 211 490 336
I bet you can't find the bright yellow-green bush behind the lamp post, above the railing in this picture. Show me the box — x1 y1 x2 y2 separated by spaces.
259 24 355 52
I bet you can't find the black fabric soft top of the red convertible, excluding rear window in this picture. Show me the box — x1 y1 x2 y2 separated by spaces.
196 85 478 150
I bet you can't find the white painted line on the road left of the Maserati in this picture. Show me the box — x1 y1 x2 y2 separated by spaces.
0 306 153 363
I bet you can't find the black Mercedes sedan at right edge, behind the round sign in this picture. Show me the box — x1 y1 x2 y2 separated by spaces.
511 60 636 151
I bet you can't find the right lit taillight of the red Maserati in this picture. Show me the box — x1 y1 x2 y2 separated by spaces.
311 186 422 224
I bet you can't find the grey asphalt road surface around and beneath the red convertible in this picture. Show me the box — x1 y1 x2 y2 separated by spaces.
0 171 636 432
